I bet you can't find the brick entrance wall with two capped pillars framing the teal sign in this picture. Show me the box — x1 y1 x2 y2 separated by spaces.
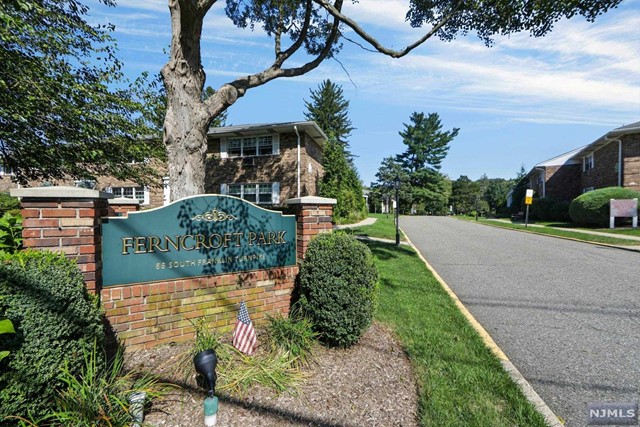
12 187 335 350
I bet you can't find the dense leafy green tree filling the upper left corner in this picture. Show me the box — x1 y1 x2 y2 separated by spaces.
0 0 164 184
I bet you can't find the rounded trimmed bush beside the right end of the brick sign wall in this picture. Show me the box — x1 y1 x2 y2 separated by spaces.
299 233 378 348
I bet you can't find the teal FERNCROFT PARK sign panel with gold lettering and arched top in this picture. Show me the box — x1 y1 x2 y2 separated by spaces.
102 196 296 286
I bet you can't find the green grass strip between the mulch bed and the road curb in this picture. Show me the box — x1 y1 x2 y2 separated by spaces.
364 239 546 427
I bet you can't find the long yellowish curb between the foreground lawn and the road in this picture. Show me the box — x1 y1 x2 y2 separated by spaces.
402 231 563 427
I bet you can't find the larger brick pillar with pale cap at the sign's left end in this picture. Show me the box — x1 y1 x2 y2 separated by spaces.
11 187 113 293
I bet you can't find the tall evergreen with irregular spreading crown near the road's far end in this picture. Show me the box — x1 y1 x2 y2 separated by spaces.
396 112 459 214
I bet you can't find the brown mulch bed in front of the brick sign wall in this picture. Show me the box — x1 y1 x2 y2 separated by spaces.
126 323 417 427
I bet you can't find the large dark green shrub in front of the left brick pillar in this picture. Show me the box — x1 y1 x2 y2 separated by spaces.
0 251 104 420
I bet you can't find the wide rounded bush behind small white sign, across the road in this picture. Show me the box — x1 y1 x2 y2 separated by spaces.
569 187 640 227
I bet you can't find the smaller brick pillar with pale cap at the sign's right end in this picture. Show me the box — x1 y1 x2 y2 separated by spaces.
284 196 337 260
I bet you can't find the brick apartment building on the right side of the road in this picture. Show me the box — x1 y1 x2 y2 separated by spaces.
527 122 640 201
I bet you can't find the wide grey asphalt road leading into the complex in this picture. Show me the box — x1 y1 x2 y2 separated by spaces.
400 217 640 427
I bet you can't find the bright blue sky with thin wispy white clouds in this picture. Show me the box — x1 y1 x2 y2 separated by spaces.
87 0 640 185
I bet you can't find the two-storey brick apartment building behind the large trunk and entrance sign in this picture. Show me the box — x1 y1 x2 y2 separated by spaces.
0 121 327 209
